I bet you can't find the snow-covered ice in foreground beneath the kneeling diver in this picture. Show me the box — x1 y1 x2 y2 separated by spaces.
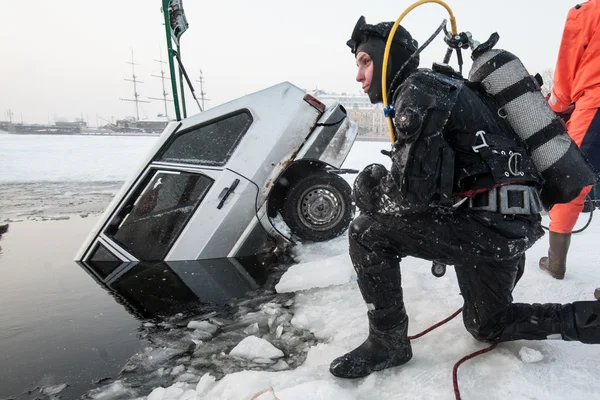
113 142 600 400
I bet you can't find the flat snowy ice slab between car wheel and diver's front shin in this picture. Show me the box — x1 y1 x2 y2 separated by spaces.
275 254 354 293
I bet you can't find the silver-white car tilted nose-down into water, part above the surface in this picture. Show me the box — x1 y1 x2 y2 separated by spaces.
76 82 357 262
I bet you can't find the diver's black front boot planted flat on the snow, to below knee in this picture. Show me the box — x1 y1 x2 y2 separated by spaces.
329 262 412 378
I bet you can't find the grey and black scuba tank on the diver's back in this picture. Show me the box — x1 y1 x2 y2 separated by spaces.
468 33 598 210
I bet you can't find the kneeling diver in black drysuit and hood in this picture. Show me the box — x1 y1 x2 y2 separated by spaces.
330 17 600 378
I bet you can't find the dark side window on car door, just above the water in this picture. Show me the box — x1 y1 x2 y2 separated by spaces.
105 171 213 261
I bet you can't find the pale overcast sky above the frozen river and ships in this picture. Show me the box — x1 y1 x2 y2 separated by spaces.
0 0 576 125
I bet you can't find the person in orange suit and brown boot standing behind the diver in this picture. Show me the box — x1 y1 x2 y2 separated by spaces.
539 0 600 279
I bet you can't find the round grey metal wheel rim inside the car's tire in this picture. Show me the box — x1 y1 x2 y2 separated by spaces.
298 186 344 231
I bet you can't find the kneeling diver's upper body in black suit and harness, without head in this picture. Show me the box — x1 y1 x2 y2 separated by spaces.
383 66 541 212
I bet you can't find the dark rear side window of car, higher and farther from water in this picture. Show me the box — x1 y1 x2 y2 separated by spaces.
158 110 252 166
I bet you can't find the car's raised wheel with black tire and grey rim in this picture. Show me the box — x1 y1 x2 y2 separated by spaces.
281 171 355 242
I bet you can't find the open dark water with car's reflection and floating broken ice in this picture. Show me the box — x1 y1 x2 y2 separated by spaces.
0 216 300 399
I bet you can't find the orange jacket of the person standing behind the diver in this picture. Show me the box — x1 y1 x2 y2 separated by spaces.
549 0 600 112
